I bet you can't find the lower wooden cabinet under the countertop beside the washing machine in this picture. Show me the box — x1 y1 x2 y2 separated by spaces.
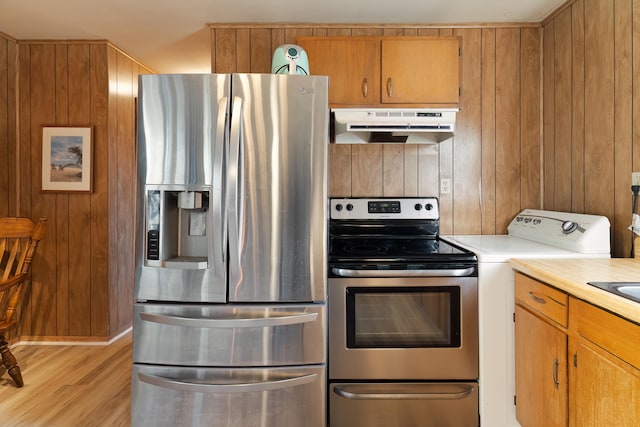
515 273 640 427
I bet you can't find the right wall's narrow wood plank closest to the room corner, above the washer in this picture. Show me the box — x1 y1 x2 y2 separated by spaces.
542 21 556 210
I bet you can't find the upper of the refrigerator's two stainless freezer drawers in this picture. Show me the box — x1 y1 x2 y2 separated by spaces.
133 303 327 366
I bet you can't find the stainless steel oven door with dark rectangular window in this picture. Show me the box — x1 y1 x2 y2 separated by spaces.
328 277 478 381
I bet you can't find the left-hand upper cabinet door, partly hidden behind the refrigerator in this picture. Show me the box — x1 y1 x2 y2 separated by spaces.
297 38 380 105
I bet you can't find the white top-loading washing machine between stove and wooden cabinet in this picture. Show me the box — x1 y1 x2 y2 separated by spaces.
441 209 610 427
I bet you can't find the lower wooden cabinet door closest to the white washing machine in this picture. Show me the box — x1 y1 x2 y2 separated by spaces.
515 306 568 427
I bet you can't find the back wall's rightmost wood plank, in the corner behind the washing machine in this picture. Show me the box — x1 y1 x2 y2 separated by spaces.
520 28 542 209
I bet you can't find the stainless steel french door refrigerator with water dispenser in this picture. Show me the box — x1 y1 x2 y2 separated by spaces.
131 74 328 427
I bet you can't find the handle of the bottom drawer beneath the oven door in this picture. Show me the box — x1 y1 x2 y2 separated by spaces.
333 384 473 400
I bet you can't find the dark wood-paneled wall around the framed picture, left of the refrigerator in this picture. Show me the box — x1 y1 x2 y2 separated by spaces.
11 41 154 340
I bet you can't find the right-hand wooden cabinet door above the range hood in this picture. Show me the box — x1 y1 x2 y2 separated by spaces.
381 37 460 104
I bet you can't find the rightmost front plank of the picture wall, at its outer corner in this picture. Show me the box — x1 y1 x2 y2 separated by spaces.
88 44 109 337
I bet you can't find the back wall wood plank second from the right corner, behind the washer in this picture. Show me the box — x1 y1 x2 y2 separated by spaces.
496 28 521 233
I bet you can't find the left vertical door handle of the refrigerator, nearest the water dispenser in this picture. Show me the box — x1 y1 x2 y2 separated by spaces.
212 96 229 270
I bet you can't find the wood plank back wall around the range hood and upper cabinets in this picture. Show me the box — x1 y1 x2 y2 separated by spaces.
210 24 542 234
